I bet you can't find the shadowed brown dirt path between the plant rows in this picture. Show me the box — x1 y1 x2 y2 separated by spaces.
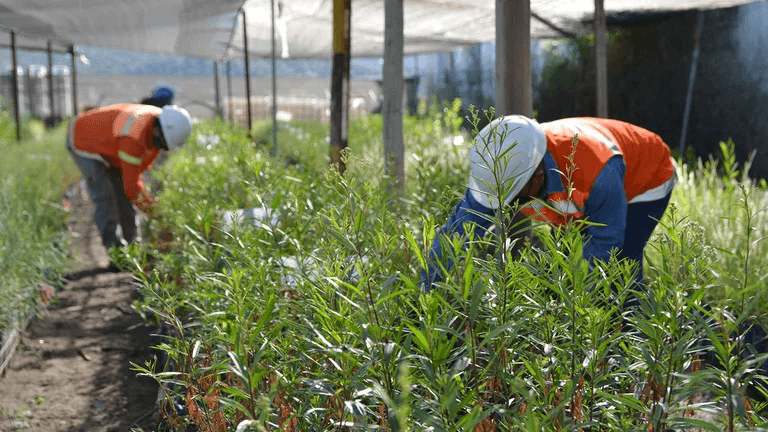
0 185 158 432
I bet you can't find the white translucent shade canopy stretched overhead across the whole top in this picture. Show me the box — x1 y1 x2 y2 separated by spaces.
0 0 755 60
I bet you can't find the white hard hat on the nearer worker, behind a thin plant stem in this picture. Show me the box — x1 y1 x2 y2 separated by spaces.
469 115 547 209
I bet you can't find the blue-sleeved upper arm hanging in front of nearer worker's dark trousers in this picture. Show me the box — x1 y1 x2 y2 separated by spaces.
584 156 627 264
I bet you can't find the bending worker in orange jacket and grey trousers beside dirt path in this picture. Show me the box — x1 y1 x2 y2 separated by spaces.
67 104 192 260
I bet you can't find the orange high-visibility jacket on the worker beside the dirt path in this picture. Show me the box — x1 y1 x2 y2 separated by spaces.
72 104 162 213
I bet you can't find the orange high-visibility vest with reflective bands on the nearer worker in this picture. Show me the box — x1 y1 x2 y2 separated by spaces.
521 117 675 225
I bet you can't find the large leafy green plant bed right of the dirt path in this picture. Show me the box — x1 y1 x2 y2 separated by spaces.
121 106 768 431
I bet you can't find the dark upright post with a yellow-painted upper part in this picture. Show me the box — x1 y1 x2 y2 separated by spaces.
330 0 354 174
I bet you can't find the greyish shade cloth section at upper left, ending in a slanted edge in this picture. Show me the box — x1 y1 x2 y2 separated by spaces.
0 0 242 55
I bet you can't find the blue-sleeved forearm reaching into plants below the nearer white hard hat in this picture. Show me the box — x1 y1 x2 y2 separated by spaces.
421 189 493 289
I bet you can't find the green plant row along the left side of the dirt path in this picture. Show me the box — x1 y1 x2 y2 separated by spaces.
0 119 76 371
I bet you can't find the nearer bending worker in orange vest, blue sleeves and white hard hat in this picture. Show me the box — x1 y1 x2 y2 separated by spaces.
422 115 675 304
